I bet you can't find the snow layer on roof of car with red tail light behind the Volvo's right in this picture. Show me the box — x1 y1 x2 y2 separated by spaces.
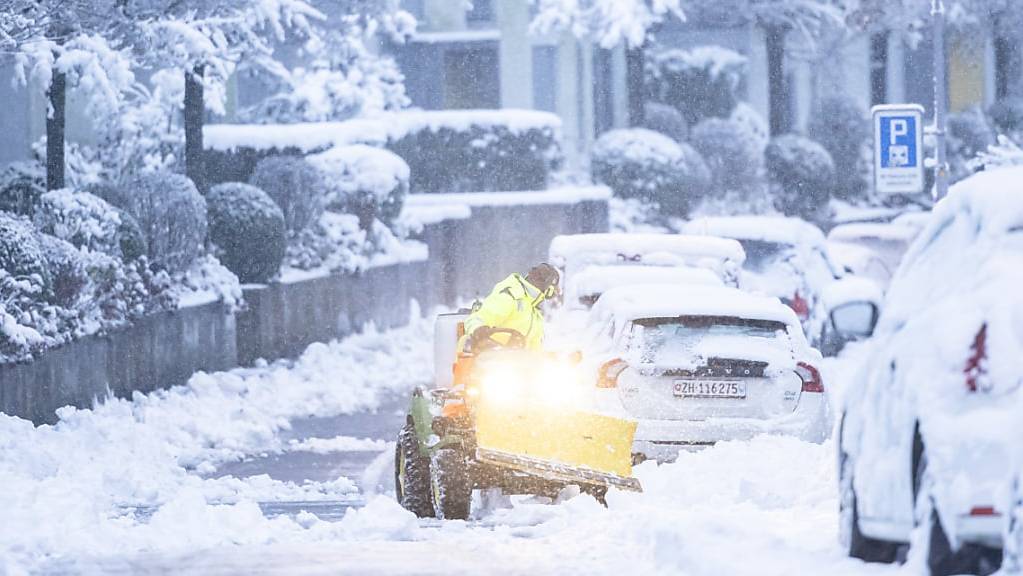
682 216 825 246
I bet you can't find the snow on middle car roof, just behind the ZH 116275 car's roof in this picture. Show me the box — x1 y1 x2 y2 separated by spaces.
572 265 724 296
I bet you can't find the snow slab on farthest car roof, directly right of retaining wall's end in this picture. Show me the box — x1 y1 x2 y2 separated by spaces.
549 233 746 269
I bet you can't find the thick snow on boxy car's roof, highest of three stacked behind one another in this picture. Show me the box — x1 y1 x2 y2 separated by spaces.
549 233 746 267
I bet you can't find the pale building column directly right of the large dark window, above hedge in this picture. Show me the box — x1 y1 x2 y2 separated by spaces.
496 0 533 108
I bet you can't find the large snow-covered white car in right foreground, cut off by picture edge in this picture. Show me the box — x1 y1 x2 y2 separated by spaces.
839 167 1023 574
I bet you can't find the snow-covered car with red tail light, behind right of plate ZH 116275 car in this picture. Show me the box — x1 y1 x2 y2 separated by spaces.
682 216 842 344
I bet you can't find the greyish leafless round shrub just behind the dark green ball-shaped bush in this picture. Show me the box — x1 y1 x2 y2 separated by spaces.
249 156 324 234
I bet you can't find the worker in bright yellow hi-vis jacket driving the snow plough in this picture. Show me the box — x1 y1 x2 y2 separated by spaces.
462 264 559 350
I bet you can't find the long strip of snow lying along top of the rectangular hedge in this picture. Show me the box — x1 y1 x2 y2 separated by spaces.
203 108 562 152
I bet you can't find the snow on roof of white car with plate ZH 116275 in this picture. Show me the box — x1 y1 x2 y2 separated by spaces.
592 284 800 326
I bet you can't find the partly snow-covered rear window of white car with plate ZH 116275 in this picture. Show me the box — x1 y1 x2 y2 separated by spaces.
633 316 790 363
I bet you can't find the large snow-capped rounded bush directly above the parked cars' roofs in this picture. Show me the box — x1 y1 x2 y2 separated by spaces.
590 128 710 216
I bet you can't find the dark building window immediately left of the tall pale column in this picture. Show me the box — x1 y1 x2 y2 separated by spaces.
444 47 500 109
